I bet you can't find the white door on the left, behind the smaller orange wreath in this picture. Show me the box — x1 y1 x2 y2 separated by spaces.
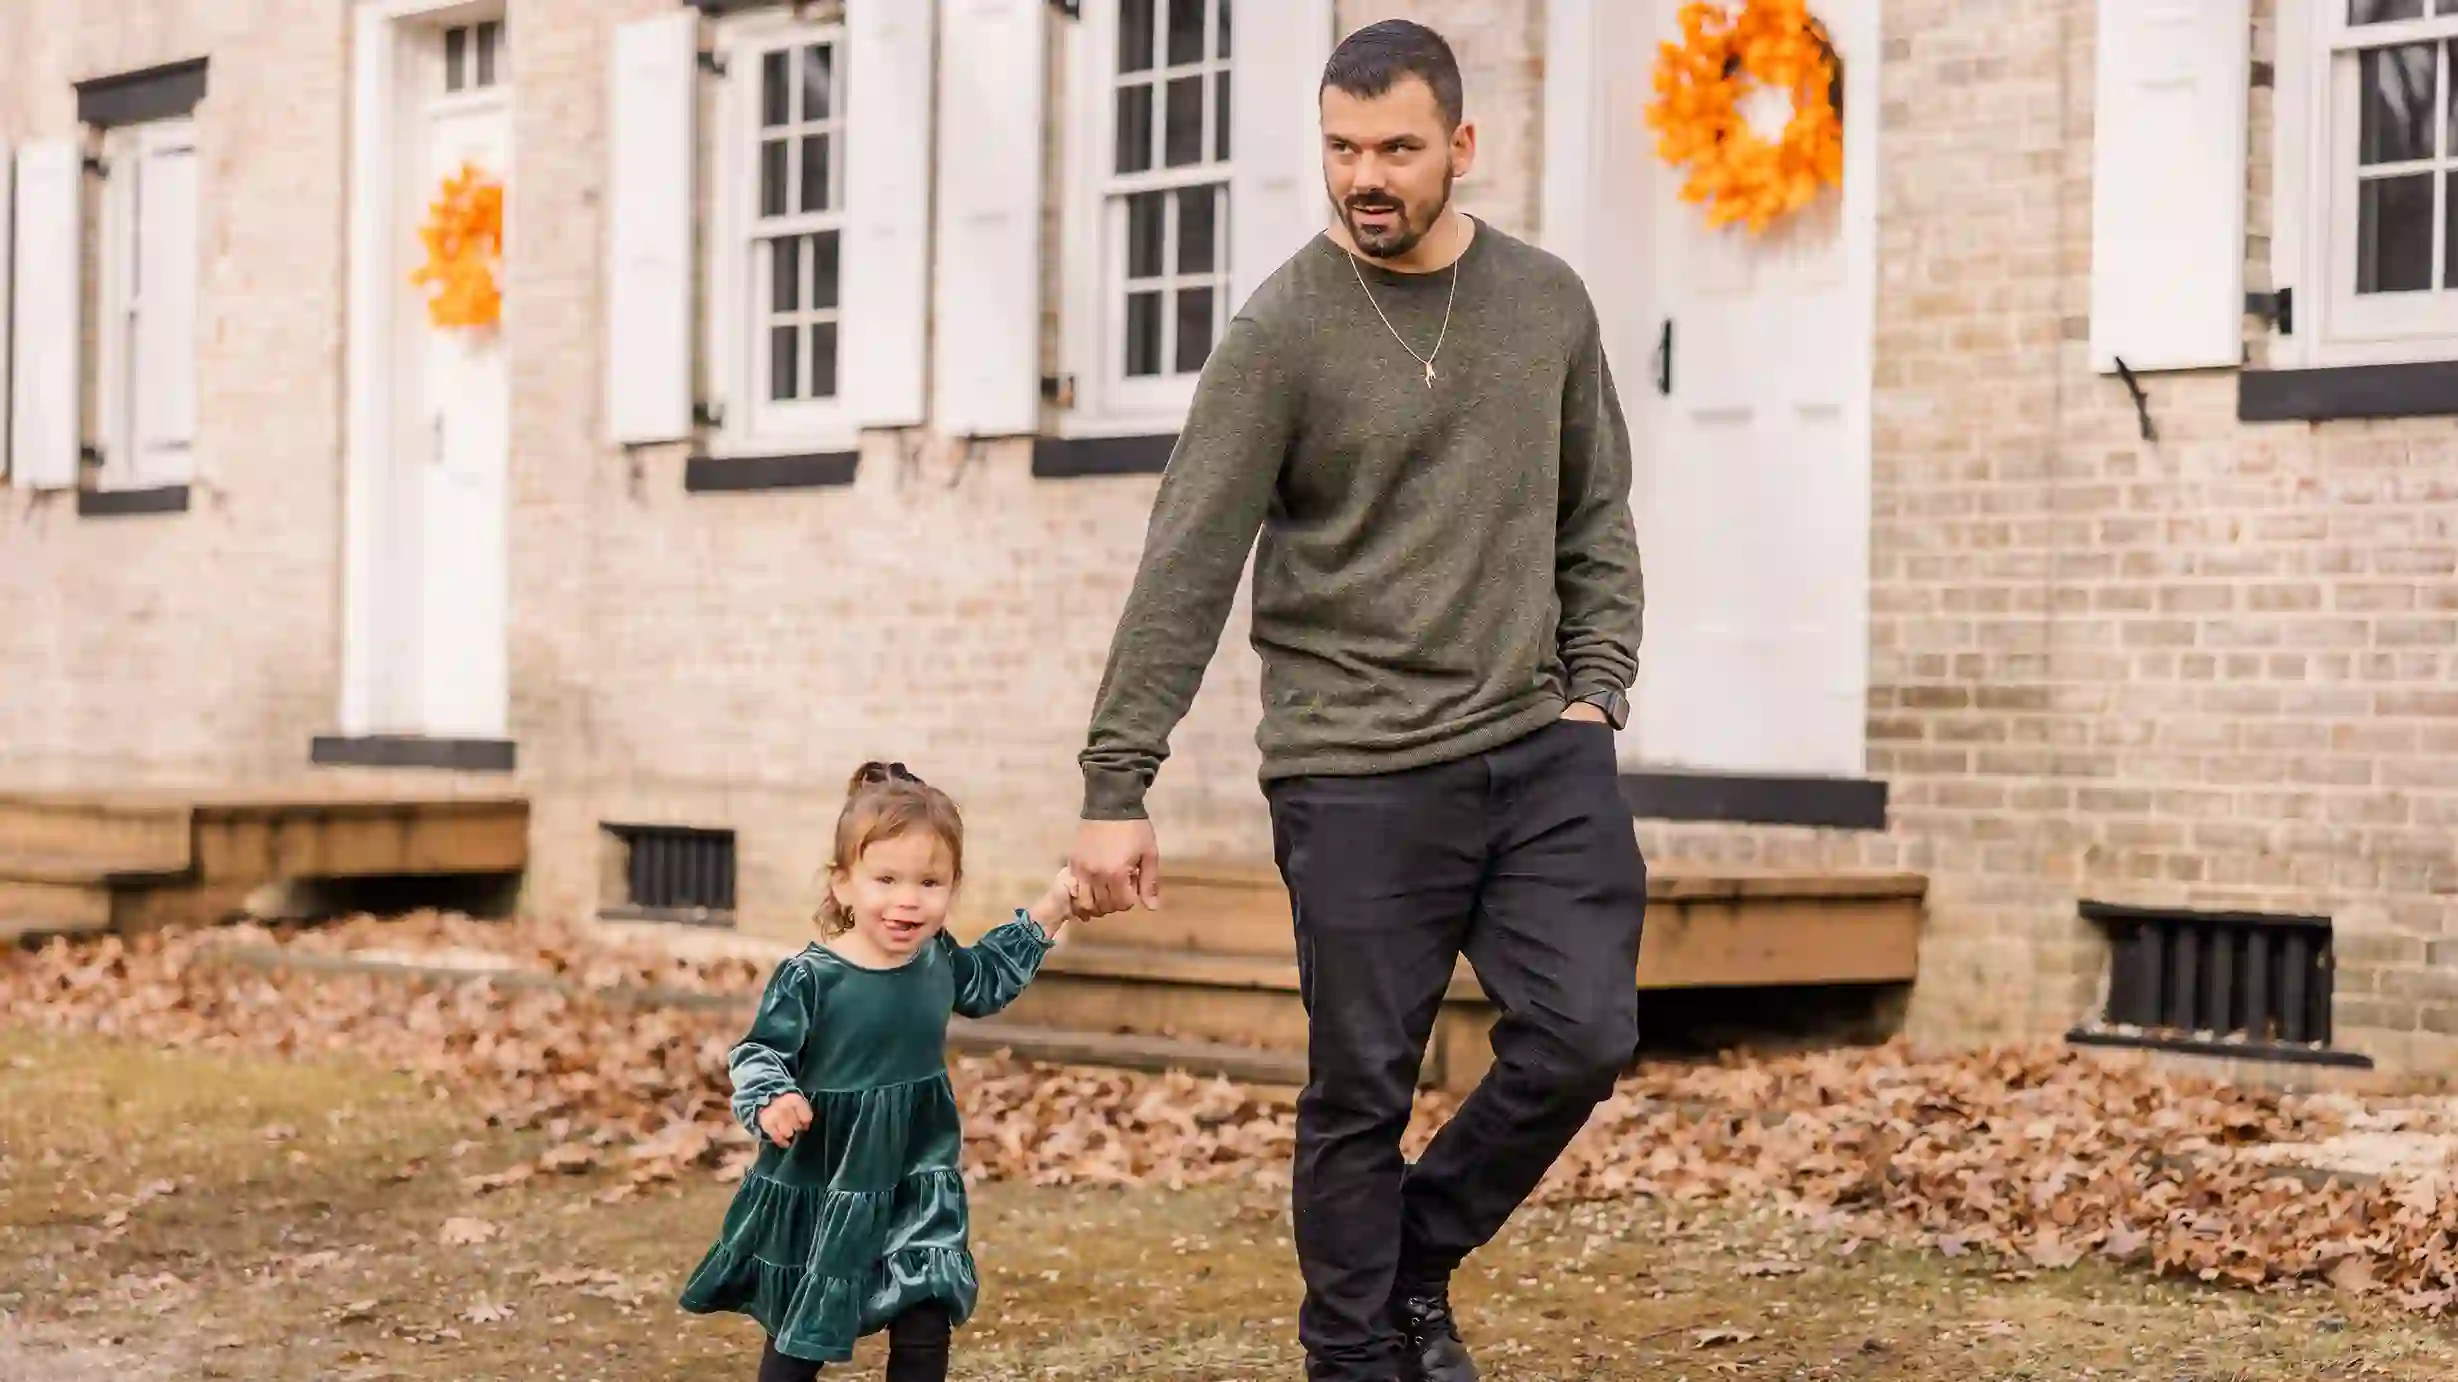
410 86 511 738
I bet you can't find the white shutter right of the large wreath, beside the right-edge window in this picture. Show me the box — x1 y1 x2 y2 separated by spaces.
2092 0 2252 374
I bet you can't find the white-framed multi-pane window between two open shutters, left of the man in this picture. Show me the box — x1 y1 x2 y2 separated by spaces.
708 12 855 452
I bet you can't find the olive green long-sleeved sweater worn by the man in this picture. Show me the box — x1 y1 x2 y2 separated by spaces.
1082 221 1639 819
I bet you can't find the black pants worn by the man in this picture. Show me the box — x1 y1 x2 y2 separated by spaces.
1266 721 1647 1382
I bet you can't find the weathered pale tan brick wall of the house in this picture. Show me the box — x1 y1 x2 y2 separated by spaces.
0 0 2458 1067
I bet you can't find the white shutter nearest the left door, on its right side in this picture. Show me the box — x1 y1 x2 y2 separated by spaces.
605 10 701 445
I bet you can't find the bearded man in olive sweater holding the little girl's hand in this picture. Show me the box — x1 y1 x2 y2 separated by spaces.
1072 20 1647 1382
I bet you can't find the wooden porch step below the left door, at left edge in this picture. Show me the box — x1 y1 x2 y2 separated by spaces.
0 782 528 942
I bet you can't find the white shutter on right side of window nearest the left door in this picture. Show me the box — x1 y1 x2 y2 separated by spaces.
841 0 929 428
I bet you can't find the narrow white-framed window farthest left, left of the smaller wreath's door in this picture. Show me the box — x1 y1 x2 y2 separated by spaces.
96 118 199 489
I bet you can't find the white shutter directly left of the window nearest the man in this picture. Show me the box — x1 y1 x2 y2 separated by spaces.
924 0 1047 438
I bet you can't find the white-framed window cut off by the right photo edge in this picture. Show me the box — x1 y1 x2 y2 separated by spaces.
2274 0 2458 366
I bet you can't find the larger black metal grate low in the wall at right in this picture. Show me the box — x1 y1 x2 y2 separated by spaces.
2082 902 2333 1045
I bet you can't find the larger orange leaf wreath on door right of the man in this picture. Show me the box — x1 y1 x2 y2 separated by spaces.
1647 0 1844 234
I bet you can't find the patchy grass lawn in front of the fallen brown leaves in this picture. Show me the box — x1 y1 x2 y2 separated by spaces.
0 1025 2458 1382
